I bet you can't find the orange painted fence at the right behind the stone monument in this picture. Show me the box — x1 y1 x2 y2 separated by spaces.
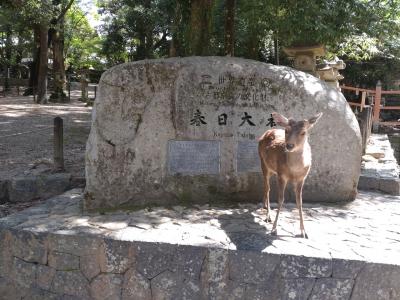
340 81 400 125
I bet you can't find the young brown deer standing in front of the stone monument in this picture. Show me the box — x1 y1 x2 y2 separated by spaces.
258 113 322 238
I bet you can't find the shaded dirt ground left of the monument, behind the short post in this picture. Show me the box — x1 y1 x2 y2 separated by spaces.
0 91 92 180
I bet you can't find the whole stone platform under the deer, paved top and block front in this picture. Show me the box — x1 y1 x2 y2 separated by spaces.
0 190 400 300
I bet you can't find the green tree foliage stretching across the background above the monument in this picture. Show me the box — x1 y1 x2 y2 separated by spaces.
0 0 400 86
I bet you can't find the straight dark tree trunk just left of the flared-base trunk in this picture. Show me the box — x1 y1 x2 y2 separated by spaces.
36 24 48 104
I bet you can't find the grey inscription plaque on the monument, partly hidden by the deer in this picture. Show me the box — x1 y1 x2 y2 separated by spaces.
237 141 261 172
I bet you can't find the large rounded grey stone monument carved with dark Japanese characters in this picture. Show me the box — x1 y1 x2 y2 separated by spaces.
84 57 361 210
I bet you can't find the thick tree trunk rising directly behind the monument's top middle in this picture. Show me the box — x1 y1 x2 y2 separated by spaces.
189 0 212 55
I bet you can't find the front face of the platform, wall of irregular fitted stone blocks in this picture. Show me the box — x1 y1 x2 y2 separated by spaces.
0 228 400 300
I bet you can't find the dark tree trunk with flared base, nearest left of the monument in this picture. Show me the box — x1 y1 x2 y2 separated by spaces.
50 18 67 102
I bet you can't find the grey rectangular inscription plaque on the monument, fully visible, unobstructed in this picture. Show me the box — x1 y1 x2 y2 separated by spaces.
168 141 220 175
